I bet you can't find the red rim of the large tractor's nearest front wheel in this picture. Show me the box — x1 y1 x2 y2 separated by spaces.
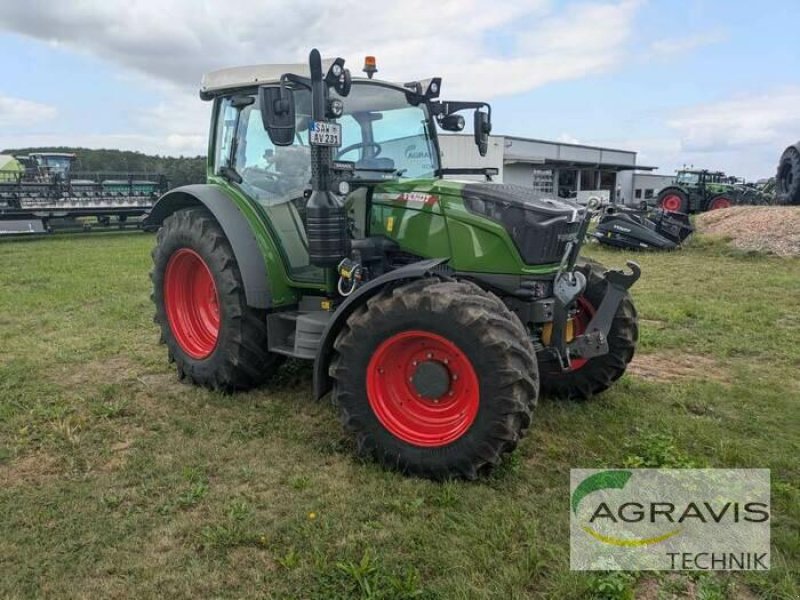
367 330 480 448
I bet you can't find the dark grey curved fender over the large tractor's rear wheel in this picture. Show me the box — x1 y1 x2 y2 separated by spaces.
143 184 272 309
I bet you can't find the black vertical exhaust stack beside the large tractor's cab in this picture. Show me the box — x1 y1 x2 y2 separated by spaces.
306 49 350 267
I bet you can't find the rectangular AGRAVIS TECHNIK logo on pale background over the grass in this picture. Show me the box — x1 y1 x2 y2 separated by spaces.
570 469 770 570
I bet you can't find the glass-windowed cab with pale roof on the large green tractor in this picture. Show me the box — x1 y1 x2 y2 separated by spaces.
201 55 496 284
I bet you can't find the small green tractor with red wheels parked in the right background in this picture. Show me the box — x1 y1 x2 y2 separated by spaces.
656 169 769 214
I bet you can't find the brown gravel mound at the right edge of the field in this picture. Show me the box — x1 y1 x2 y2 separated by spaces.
695 206 800 256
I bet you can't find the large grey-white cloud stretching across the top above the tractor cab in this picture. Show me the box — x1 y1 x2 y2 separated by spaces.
0 0 639 97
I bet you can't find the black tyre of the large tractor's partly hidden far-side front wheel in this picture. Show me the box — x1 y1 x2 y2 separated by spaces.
539 259 639 400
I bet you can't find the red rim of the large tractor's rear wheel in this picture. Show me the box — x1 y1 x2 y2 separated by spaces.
164 248 219 359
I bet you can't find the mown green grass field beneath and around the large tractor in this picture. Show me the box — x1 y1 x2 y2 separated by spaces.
0 234 800 600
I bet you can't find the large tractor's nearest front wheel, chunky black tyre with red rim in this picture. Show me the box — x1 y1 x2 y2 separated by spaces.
329 278 539 480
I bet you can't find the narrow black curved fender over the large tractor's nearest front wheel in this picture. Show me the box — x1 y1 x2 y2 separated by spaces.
314 258 452 400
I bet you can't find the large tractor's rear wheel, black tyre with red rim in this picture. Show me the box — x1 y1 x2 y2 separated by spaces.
150 208 282 392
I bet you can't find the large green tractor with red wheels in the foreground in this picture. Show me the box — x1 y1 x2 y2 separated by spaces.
147 50 640 479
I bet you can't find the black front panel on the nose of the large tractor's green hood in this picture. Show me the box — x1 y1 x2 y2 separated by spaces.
464 183 586 265
